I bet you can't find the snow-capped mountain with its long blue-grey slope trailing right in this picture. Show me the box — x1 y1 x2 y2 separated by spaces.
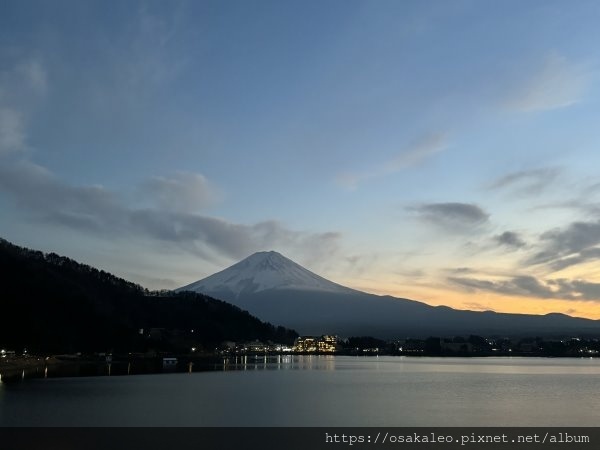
177 251 600 338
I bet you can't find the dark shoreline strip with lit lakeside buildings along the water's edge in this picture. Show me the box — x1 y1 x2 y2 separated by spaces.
0 333 600 382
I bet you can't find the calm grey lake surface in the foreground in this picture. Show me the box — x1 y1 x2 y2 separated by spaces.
0 356 600 426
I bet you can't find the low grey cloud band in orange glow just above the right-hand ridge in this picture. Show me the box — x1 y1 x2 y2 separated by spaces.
448 275 600 301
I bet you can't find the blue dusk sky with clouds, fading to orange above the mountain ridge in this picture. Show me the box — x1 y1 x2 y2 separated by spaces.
0 0 600 319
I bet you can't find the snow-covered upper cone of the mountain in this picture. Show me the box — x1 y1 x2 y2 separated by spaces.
178 251 356 297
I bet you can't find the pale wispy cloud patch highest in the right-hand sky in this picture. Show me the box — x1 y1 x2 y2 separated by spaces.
506 54 590 112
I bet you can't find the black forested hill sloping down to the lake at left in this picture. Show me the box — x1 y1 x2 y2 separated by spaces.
0 239 296 352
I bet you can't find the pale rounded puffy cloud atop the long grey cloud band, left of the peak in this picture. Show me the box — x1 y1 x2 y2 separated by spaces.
140 172 221 212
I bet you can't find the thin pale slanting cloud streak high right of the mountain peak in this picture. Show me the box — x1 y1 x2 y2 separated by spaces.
336 133 447 189
